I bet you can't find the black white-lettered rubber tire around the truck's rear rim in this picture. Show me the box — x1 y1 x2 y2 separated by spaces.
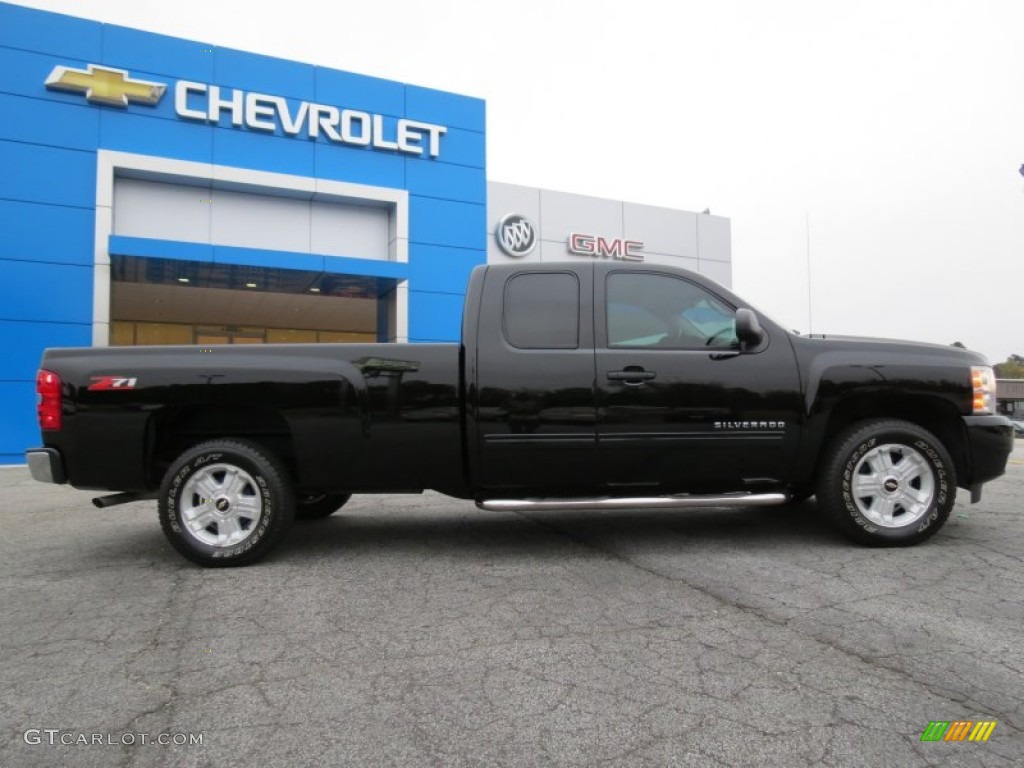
159 440 294 566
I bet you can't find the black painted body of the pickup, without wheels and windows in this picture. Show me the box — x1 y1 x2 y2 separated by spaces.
28 262 1013 499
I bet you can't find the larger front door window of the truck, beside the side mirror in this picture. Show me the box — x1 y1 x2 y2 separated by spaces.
606 272 738 349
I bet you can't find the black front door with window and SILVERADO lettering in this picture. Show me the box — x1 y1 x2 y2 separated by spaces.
595 264 801 493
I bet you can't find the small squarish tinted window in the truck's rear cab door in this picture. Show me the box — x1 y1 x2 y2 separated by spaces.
504 272 580 349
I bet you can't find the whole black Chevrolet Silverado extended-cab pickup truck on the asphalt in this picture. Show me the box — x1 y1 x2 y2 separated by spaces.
27 261 1014 565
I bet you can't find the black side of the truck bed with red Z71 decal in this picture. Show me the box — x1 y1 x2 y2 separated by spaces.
43 344 465 496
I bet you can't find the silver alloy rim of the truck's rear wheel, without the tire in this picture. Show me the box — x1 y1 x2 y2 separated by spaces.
178 464 263 548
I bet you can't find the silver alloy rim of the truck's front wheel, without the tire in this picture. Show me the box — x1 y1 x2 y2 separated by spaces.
851 443 935 528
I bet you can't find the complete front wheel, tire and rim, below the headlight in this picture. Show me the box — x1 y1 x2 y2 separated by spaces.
817 419 956 547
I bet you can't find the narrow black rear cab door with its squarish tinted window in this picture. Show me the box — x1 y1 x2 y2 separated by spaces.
467 263 596 495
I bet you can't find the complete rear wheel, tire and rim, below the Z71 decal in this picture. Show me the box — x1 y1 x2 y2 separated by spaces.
160 439 295 567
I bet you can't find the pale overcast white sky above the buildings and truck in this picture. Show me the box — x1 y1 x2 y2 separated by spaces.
19 0 1024 362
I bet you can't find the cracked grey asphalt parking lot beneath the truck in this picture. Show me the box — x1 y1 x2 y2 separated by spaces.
0 440 1024 768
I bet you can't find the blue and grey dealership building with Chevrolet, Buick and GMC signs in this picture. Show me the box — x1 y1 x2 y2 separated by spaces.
0 3 731 464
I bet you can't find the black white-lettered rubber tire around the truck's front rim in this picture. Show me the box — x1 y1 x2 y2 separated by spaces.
818 422 956 545
